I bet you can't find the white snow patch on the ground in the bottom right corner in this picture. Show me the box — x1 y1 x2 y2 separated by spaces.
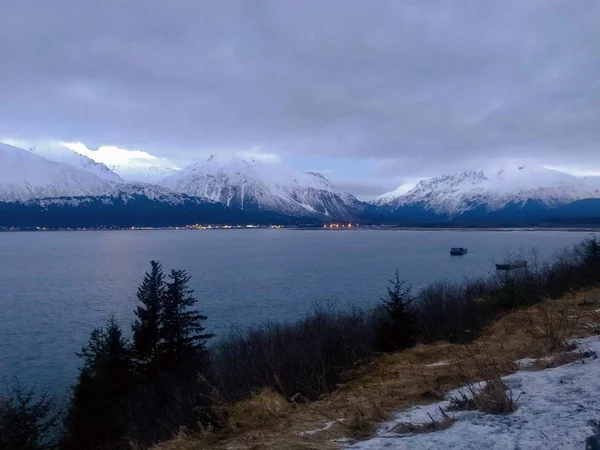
348 336 600 450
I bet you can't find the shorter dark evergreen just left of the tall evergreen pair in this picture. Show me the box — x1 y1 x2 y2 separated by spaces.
61 316 133 449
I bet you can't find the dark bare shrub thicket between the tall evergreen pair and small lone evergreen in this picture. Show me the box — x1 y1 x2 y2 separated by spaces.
213 308 375 401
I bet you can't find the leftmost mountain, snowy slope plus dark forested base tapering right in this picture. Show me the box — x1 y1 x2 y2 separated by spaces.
0 144 262 229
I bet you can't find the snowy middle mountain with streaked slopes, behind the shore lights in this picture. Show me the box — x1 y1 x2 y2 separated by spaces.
160 156 364 220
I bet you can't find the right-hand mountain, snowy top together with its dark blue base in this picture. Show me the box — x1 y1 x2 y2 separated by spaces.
372 165 600 223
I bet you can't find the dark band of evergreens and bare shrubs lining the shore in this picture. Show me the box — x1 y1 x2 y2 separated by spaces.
0 239 600 450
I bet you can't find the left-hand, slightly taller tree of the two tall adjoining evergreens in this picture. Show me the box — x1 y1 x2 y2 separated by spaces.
131 261 165 374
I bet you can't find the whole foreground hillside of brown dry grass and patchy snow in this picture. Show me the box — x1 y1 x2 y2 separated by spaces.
157 288 600 450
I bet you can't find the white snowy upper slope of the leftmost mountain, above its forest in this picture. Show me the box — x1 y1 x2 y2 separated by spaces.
0 143 113 202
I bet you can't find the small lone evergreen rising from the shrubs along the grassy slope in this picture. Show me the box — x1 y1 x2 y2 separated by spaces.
377 271 417 352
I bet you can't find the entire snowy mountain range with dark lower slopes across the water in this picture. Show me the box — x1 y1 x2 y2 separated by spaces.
0 144 600 228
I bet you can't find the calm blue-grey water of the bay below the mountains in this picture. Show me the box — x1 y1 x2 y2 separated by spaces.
0 230 588 395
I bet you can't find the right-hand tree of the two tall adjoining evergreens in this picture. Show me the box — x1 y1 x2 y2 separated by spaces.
161 270 213 370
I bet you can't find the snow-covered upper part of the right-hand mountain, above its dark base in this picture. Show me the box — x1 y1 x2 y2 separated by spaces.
372 165 600 217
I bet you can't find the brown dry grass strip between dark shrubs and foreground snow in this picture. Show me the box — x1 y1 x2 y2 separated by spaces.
158 289 600 450
